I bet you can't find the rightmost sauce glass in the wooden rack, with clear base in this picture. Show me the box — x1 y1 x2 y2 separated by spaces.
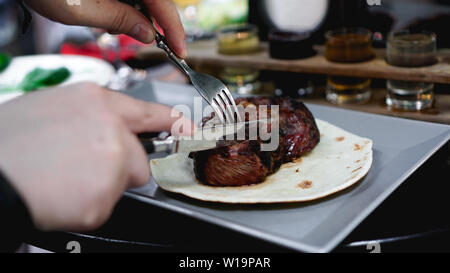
386 31 437 111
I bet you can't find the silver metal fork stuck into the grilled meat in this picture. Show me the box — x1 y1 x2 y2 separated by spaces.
121 0 242 124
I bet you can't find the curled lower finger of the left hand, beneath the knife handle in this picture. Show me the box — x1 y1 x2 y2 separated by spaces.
124 132 150 188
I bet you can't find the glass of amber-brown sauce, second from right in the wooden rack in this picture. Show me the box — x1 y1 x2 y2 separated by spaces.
325 28 374 104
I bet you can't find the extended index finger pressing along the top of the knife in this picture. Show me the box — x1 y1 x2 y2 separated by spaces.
107 92 195 136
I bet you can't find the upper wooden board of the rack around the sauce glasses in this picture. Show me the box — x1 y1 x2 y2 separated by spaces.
138 41 450 84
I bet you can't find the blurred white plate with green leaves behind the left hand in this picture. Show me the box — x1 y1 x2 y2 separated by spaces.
0 55 115 104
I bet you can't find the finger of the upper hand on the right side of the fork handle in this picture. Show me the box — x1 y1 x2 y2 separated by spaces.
144 0 187 59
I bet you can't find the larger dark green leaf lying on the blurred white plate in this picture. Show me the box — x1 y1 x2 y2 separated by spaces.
19 67 70 92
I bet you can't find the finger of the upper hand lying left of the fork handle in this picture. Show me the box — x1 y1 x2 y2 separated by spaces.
78 0 155 43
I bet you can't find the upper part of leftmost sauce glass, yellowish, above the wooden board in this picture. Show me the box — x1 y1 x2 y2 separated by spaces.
217 24 260 55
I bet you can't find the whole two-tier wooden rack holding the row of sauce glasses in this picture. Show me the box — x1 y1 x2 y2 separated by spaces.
138 41 450 124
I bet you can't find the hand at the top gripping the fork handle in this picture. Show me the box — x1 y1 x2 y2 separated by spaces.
25 0 187 59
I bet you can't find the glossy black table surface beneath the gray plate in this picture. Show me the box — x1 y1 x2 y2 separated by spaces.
22 142 450 253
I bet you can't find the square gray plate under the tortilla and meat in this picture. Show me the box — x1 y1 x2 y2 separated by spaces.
126 80 450 252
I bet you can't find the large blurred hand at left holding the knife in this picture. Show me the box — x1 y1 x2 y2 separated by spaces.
0 83 194 231
